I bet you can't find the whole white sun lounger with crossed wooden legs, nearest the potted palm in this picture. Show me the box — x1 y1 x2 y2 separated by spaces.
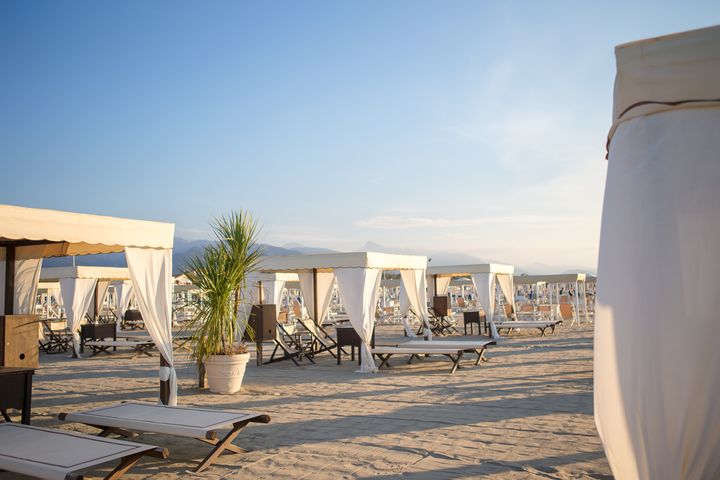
60 402 270 472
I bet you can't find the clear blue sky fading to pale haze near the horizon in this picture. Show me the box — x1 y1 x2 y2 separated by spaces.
0 0 720 270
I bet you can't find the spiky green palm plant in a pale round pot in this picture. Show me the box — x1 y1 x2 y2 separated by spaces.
187 212 262 394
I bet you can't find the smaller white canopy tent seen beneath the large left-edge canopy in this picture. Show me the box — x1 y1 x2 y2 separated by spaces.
40 266 132 356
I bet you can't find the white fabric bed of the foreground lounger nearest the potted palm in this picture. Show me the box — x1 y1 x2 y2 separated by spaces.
65 402 261 438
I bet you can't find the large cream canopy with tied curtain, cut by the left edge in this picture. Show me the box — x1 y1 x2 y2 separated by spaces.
0 205 177 404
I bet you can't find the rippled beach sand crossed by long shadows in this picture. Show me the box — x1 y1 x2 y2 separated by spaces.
0 325 611 480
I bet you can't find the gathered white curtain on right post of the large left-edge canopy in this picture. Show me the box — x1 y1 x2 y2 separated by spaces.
125 247 177 405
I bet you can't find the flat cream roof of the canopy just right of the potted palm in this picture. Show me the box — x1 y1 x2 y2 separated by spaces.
260 252 427 273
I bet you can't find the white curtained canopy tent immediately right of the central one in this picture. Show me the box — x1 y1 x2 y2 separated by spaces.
427 263 515 338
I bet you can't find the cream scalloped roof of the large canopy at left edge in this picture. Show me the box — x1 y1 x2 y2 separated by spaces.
0 205 175 257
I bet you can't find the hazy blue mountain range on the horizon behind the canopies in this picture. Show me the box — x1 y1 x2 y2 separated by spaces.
43 238 595 275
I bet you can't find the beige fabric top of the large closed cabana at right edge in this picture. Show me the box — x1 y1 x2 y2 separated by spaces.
610 26 720 137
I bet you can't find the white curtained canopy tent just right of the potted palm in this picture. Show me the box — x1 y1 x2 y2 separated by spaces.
259 252 427 372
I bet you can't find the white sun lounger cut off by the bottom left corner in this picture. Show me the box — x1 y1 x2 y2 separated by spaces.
0 423 168 480
